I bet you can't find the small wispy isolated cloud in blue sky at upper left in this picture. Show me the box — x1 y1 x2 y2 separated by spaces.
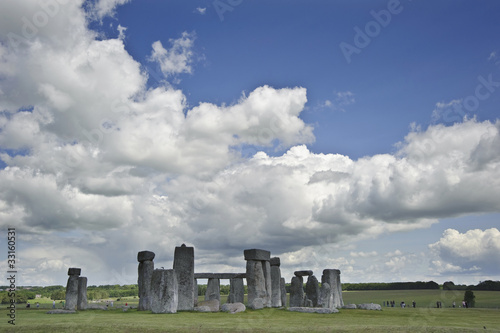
150 32 195 77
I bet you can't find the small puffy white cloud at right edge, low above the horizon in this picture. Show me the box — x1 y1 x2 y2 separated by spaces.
429 228 500 275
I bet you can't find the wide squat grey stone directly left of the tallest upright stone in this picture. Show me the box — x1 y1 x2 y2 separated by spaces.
151 269 179 313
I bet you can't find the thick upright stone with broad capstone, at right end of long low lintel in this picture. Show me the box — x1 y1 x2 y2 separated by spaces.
244 249 271 309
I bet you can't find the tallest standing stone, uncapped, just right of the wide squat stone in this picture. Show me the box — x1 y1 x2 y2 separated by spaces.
174 244 195 310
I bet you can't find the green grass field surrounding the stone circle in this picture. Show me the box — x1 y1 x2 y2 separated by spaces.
0 290 500 333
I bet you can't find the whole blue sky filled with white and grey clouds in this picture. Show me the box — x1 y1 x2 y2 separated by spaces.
0 0 500 285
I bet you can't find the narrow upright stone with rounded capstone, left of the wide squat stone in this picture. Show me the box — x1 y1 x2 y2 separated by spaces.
137 251 155 311
